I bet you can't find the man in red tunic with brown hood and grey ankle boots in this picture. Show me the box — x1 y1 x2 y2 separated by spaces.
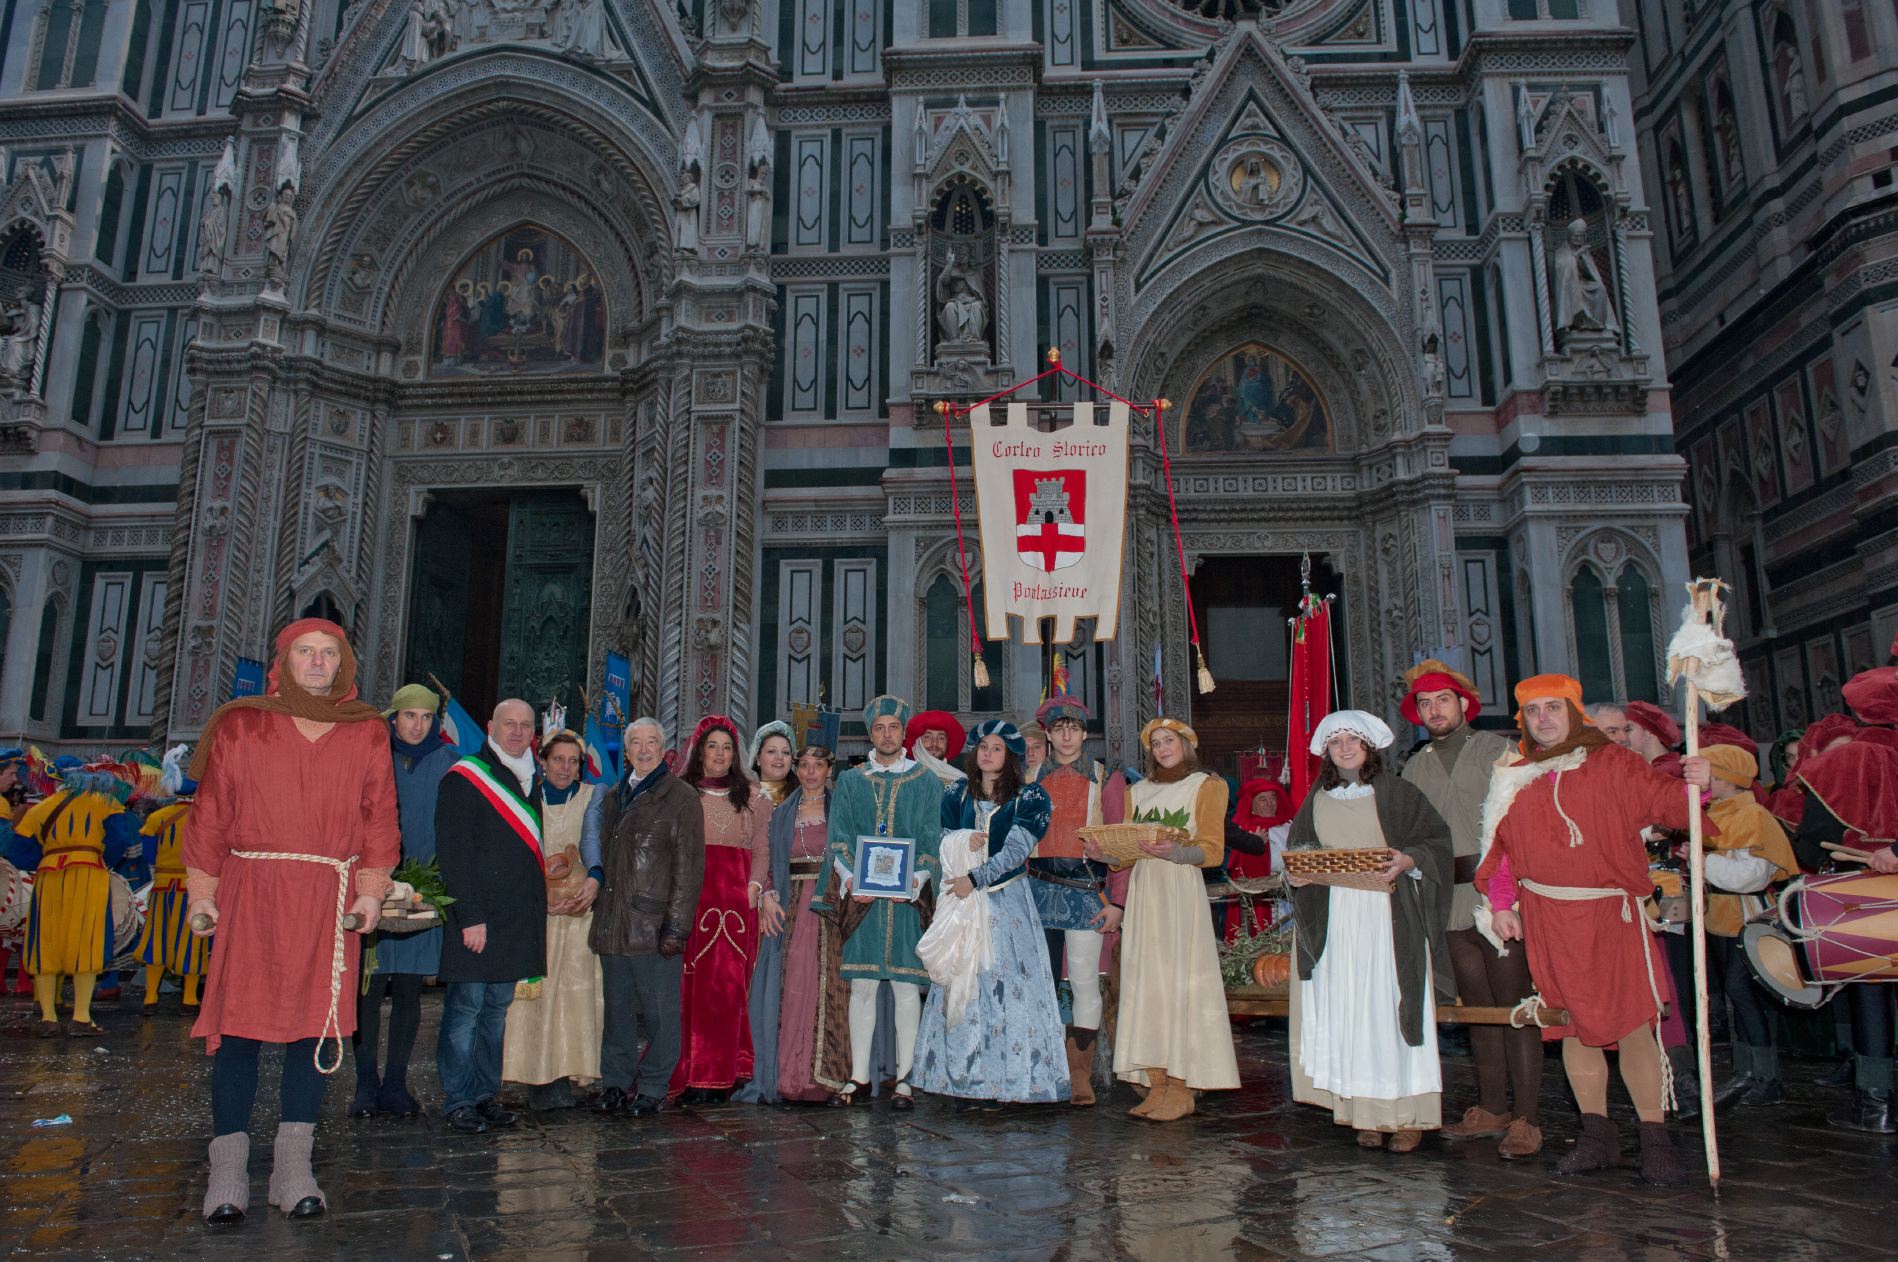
184 619 400 1222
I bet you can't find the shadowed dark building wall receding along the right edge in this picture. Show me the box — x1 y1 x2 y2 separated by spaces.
1634 0 1898 743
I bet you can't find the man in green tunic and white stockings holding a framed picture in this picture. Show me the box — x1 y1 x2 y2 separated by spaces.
812 696 943 1110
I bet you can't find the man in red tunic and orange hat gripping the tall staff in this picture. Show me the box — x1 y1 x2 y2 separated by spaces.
1477 676 1710 1186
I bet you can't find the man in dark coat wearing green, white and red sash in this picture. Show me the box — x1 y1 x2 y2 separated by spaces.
435 698 547 1135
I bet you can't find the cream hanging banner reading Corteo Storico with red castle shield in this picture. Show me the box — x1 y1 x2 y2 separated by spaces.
970 402 1129 643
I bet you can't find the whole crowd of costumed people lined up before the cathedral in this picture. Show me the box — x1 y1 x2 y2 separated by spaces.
0 619 1898 1224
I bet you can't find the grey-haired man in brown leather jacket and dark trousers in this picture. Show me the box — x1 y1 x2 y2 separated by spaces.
588 719 706 1118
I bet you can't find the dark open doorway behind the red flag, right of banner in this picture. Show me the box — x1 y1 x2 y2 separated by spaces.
1188 556 1344 772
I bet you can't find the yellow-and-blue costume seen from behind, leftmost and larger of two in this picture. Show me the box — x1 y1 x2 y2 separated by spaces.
13 789 129 1034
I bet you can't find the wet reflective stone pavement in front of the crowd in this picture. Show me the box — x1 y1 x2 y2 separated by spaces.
0 989 1898 1262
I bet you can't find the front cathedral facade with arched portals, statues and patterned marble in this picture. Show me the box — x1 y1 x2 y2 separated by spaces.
0 0 1700 753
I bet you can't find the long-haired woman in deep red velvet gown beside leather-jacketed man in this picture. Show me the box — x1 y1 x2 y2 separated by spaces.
672 714 784 1104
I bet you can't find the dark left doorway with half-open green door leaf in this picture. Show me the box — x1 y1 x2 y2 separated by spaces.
402 488 594 721
